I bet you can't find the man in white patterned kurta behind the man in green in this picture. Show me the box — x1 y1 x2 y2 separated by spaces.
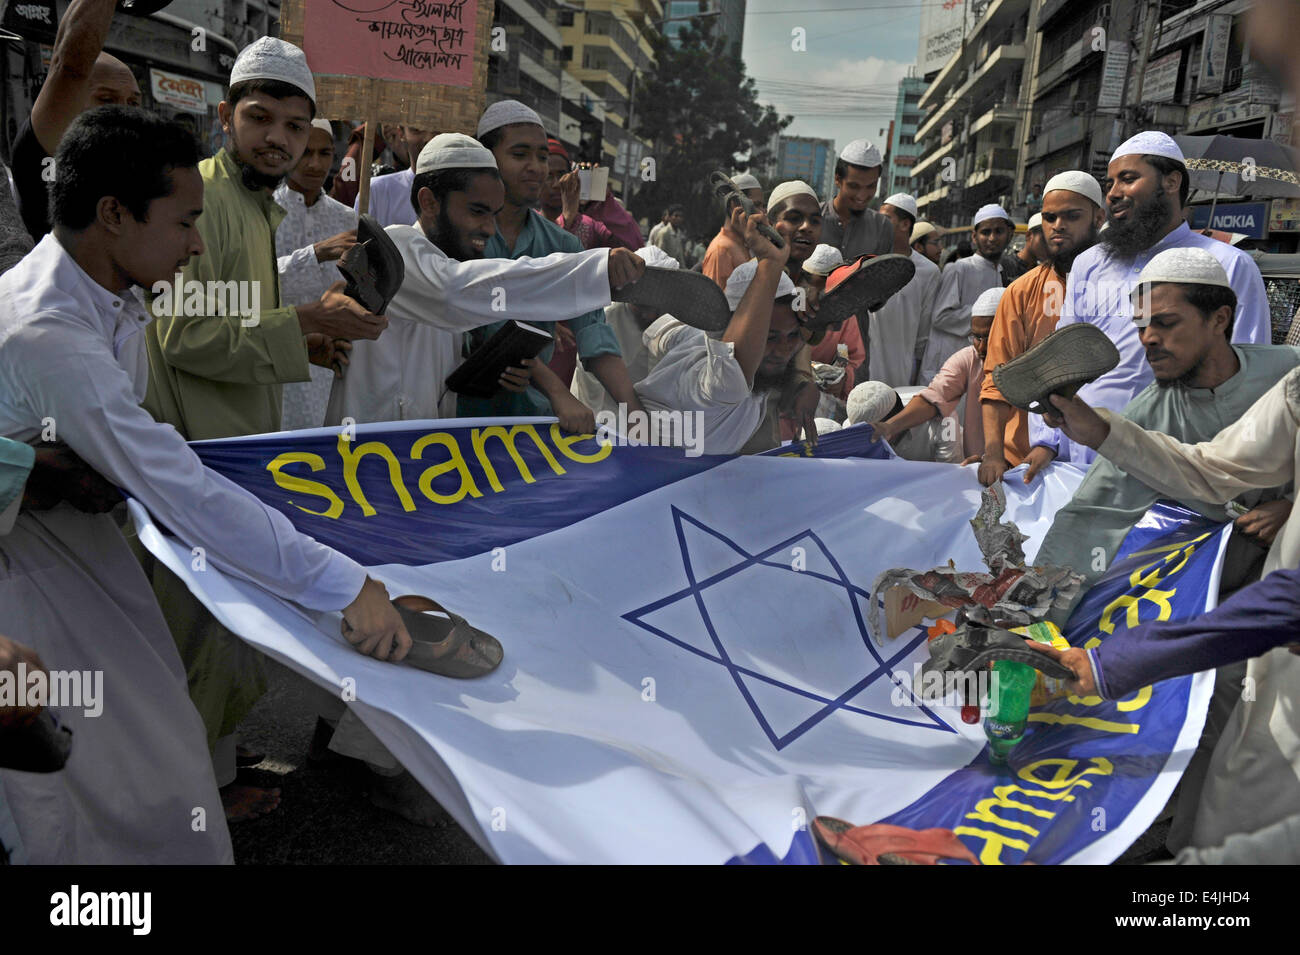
272 118 356 431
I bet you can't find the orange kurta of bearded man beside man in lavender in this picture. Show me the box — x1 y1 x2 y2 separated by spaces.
980 265 1065 468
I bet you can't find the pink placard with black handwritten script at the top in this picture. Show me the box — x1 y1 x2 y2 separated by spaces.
303 0 478 86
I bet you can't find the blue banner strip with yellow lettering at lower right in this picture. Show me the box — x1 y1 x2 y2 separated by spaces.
880 503 1230 864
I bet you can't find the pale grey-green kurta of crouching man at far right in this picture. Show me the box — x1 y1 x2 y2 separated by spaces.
1034 344 1300 595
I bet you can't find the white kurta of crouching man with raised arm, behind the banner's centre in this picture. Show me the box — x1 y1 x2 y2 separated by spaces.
636 314 767 455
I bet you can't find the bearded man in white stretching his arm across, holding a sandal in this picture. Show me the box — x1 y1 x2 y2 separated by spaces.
325 133 645 425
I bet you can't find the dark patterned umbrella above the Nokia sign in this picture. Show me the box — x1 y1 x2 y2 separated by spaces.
1174 136 1300 222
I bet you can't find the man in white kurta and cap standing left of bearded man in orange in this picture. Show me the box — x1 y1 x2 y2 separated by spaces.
918 204 1015 381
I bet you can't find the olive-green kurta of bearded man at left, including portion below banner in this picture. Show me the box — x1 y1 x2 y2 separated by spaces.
144 149 311 748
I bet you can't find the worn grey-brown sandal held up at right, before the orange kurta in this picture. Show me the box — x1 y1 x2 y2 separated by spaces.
993 322 1119 414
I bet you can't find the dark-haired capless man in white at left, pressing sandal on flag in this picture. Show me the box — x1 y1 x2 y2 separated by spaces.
0 105 411 864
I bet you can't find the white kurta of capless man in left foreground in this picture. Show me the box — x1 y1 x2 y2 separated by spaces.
0 235 365 864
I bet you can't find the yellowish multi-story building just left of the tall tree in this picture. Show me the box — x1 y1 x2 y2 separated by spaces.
558 0 663 191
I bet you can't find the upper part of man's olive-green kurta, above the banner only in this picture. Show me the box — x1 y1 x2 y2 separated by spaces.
144 149 311 440
